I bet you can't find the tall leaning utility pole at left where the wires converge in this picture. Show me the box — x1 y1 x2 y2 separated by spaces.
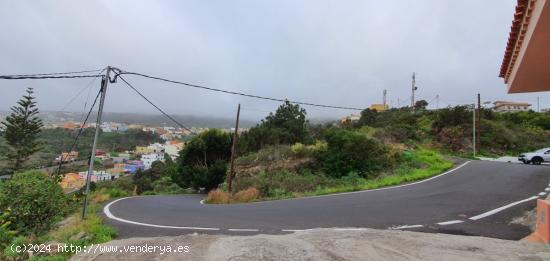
82 66 111 219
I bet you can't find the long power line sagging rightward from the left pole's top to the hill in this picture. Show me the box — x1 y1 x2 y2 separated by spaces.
115 69 364 111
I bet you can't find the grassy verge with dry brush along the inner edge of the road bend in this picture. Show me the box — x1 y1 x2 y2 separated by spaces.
222 142 453 203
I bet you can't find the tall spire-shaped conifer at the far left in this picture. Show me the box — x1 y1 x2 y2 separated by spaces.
0 88 43 172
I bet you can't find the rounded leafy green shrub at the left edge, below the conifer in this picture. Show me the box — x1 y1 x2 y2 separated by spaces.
0 171 69 234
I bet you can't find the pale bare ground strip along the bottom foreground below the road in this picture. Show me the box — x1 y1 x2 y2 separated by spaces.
72 226 550 261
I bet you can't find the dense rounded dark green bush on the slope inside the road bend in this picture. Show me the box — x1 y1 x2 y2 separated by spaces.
318 129 396 177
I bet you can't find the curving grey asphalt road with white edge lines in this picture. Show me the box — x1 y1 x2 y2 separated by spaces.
104 161 550 239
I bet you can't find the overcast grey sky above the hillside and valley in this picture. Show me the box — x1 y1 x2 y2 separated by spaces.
0 0 550 119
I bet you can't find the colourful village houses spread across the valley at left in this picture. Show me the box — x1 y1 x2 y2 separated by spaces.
51 121 244 192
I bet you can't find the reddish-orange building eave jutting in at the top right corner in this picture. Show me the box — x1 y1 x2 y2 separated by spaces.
499 0 550 93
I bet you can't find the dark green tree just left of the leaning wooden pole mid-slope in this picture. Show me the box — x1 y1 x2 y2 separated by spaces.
172 129 231 190
